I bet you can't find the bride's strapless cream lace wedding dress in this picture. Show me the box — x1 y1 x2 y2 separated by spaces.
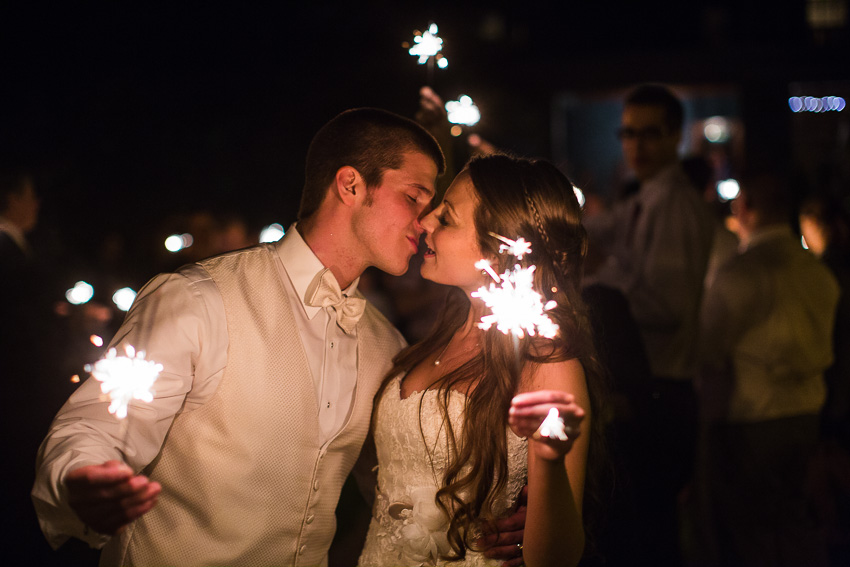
358 377 528 567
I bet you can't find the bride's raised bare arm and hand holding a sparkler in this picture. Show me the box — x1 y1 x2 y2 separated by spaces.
509 360 592 567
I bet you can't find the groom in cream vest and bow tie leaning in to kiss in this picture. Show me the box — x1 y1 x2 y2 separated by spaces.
33 109 520 565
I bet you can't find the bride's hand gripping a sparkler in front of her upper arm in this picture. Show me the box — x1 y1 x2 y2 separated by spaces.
508 390 584 461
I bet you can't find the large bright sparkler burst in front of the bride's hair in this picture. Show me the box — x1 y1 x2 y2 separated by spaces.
472 233 558 339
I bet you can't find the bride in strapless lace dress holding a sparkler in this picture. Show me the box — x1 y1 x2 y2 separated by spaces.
359 155 600 566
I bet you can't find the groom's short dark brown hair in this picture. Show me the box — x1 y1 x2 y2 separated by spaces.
298 108 446 219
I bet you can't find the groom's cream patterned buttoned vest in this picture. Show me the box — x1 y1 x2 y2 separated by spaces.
101 245 403 567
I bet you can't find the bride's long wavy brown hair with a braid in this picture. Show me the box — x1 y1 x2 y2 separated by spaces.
376 154 602 559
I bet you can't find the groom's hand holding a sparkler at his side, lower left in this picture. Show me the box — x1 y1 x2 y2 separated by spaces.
65 461 161 535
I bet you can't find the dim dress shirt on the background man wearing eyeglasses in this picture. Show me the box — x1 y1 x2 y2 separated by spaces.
583 164 714 379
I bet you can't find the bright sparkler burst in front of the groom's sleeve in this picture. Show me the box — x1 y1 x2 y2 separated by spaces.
85 345 162 419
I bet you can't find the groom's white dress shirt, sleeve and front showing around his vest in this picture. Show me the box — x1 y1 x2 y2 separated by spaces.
33 225 359 547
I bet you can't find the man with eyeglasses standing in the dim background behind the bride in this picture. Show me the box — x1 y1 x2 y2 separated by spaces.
586 85 714 565
